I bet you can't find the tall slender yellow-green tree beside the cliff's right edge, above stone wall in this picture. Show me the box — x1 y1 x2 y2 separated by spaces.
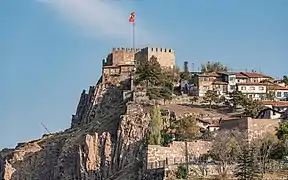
148 105 162 145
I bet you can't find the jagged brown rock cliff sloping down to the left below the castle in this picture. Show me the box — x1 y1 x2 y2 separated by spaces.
0 85 150 180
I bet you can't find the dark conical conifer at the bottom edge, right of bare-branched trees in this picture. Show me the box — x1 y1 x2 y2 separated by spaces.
235 145 260 180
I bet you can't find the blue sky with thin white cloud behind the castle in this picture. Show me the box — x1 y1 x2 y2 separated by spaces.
0 0 288 149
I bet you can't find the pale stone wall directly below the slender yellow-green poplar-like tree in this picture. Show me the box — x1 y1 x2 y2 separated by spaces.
148 140 211 165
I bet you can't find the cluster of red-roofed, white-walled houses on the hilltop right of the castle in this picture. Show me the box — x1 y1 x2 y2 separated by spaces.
181 72 288 100
